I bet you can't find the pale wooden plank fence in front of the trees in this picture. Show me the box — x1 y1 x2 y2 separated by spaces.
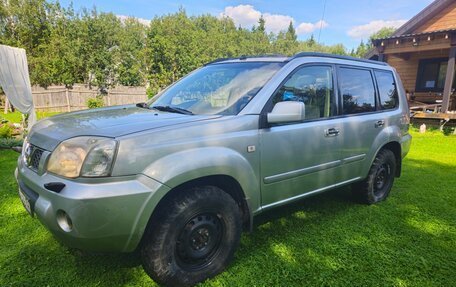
0 85 147 112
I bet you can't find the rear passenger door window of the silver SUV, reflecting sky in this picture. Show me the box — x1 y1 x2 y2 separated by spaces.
339 67 375 115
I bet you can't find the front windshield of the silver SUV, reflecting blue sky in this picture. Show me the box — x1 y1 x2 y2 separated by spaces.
149 62 284 115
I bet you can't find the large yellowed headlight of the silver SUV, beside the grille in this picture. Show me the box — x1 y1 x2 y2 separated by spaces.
47 137 117 178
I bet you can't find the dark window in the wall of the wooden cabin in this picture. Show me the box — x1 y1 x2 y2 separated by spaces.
416 58 448 92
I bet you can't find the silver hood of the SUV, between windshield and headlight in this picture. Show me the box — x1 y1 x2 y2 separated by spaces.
28 105 220 150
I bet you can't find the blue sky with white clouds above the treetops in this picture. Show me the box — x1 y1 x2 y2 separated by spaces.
60 0 432 49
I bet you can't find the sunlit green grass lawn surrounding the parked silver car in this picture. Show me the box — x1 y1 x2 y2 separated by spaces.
0 132 456 286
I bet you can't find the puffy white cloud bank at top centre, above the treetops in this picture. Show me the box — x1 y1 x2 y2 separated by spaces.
219 5 328 35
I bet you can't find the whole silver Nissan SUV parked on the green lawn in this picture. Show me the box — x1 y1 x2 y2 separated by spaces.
16 53 411 286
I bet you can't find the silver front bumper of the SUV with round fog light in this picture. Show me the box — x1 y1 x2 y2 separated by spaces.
15 158 169 252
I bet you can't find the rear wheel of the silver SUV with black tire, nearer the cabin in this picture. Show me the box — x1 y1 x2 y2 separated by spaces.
352 149 396 204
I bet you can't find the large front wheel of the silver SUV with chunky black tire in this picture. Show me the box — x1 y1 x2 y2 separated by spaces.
141 186 242 286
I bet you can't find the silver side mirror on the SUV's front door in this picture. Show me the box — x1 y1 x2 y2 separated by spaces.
268 101 305 124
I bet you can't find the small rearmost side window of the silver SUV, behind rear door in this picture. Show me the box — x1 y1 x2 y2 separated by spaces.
374 70 398 110
